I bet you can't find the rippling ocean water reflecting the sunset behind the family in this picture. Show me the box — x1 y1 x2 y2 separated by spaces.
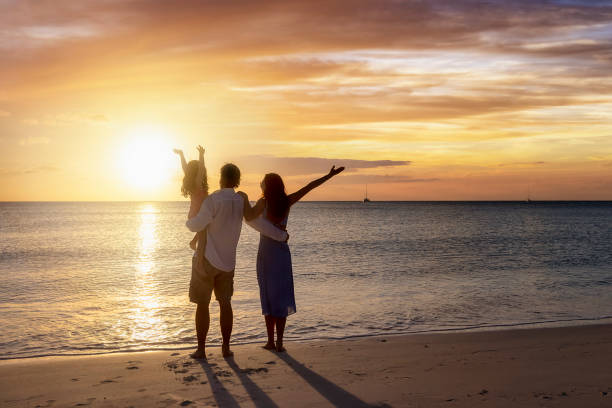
0 202 612 359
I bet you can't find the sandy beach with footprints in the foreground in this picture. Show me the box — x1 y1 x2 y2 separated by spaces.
0 325 612 407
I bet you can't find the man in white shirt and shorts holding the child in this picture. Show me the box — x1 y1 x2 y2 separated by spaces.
186 163 289 359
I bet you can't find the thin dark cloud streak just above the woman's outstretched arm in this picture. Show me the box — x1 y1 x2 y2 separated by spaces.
237 155 411 176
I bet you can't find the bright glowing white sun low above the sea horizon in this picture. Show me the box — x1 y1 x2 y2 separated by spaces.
119 125 175 189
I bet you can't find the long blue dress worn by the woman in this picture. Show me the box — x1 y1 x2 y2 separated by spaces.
257 212 296 317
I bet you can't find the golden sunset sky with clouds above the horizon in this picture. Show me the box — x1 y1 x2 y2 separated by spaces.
0 0 612 201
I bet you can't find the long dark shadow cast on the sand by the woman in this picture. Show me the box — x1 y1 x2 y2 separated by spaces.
277 353 390 408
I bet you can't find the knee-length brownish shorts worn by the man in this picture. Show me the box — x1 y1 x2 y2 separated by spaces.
189 256 234 305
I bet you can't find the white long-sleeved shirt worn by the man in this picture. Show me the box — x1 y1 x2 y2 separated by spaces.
186 188 288 272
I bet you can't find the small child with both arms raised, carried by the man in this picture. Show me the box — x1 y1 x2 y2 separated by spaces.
174 145 208 251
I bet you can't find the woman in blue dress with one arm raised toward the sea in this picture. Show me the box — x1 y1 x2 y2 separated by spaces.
257 166 344 352
